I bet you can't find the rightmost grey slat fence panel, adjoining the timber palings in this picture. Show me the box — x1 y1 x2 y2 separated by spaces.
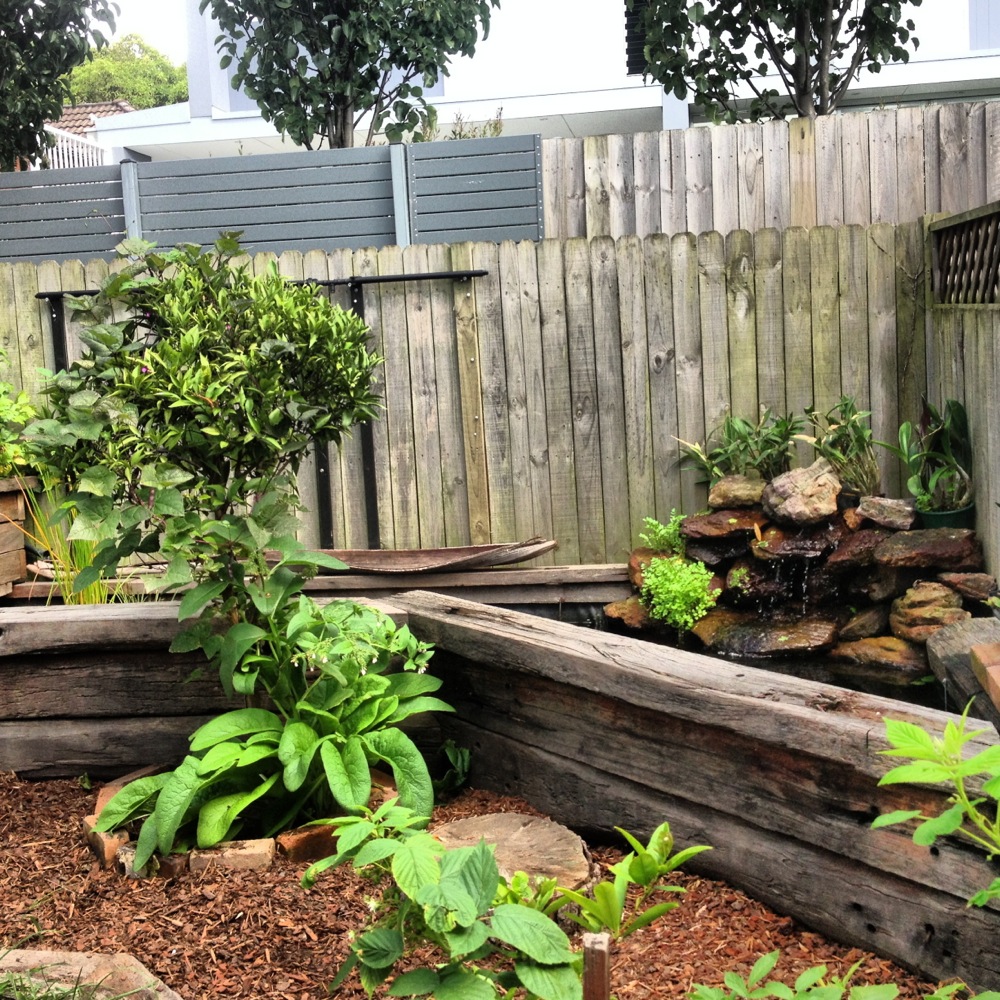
407 135 544 243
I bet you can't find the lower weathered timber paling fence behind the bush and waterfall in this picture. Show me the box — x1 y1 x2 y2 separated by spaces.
0 224 927 564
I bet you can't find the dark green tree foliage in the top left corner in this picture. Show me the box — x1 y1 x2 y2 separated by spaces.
0 0 118 170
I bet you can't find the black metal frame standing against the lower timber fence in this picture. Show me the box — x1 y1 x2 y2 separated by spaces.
35 270 489 549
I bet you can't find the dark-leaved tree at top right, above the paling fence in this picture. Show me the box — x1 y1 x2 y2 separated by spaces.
626 0 921 121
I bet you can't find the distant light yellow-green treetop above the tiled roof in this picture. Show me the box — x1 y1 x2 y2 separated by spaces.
69 35 187 109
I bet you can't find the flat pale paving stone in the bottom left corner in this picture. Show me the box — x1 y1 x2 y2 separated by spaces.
0 949 181 1000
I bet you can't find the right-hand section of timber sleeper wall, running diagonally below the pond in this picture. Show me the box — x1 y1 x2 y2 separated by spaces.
396 593 1000 989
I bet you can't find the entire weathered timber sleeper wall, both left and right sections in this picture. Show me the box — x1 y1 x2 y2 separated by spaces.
0 592 1000 991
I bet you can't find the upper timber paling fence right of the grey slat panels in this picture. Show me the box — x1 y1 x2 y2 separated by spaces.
542 102 1000 238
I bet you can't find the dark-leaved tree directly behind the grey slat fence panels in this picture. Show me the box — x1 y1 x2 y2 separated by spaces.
201 0 499 149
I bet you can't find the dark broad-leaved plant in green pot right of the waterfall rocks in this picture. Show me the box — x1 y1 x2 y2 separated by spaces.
880 399 975 511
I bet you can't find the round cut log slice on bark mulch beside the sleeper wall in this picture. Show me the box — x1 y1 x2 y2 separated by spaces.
430 813 590 889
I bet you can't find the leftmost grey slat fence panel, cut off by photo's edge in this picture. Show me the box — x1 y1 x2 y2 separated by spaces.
0 166 125 263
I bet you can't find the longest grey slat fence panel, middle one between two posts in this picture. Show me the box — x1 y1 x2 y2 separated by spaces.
137 146 396 253
